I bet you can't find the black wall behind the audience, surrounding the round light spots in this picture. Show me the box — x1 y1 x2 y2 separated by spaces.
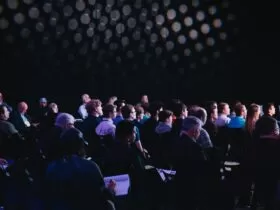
0 0 279 110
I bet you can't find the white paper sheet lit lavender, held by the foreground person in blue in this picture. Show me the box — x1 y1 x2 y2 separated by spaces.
104 174 130 196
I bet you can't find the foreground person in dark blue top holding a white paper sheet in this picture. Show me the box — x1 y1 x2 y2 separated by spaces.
45 128 116 210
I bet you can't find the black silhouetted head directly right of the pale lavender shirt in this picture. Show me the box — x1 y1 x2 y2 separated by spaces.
116 120 135 143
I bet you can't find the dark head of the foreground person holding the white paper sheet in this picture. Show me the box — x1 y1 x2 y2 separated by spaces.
59 128 87 157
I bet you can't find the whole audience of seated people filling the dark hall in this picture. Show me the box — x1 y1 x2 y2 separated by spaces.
0 94 280 210
